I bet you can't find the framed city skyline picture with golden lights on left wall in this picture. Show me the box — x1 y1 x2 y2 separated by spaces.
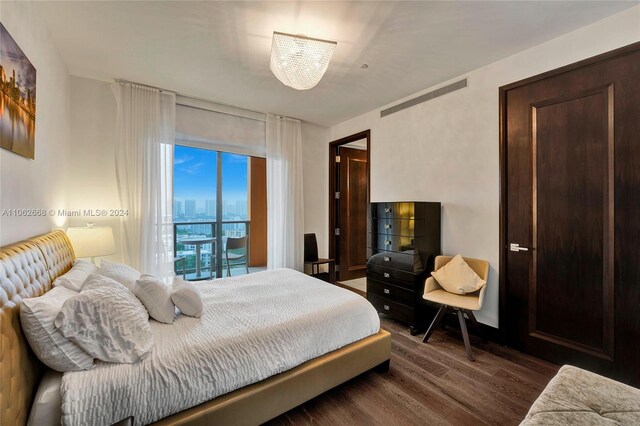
0 22 36 159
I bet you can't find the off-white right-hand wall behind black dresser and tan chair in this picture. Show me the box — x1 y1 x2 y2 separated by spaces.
330 6 640 327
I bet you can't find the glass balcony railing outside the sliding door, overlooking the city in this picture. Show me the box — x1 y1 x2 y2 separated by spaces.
173 220 251 280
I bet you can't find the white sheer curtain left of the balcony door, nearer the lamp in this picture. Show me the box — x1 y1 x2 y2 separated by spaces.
112 83 176 280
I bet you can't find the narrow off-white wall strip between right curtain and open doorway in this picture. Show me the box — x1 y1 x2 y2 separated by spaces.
302 123 329 257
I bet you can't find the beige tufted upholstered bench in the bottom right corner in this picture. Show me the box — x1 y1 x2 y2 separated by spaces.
521 365 640 426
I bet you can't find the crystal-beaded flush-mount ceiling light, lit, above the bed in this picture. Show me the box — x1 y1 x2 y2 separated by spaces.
270 31 338 90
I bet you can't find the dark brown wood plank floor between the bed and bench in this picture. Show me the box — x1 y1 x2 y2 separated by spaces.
268 319 559 426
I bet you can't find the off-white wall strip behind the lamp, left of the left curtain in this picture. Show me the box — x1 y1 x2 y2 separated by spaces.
67 76 122 262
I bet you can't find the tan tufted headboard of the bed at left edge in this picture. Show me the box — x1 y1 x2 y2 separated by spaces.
0 231 75 425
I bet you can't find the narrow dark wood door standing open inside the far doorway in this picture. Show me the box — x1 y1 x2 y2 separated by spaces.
338 147 368 281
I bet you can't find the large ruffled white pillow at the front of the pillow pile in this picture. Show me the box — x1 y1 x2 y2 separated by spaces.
55 274 153 364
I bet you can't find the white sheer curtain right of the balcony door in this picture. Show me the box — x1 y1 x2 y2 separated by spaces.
267 115 304 271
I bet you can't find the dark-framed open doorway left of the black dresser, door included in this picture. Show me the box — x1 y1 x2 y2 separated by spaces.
328 130 371 281
